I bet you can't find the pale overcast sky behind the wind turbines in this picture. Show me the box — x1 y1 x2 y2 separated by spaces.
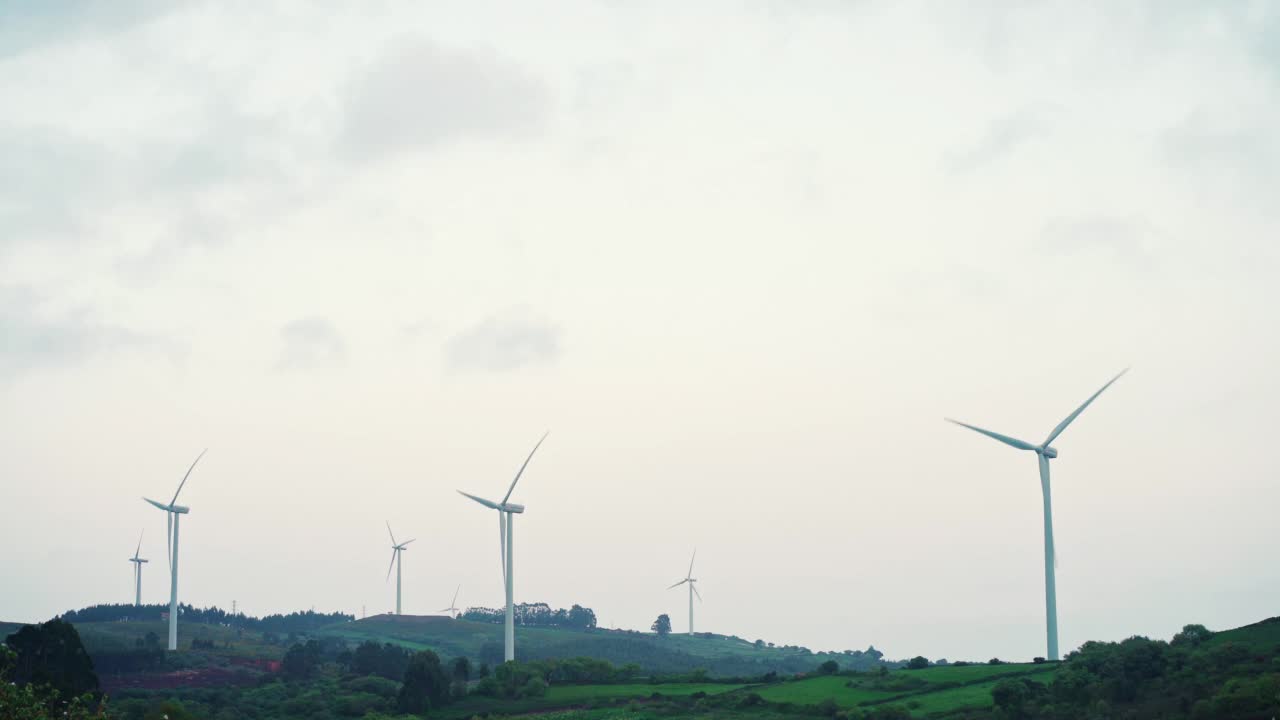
0 0 1280 660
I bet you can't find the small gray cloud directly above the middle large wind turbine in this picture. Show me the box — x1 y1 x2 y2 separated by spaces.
444 311 561 372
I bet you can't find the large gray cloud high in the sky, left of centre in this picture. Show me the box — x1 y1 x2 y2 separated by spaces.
342 40 549 156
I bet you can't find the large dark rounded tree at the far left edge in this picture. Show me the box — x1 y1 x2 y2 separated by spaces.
5 618 99 697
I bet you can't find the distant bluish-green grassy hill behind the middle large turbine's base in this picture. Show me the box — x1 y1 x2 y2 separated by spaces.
319 607 852 676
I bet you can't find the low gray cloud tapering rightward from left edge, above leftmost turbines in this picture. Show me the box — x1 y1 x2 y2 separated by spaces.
0 288 180 379
